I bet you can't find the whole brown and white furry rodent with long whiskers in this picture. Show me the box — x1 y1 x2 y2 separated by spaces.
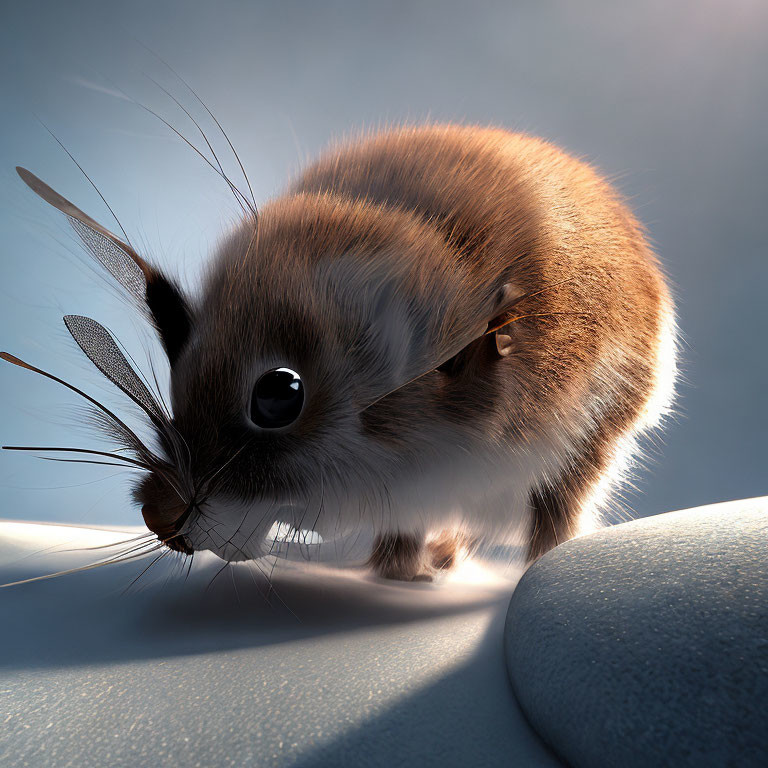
9 125 676 580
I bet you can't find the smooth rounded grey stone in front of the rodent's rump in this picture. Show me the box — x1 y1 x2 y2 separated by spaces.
505 497 768 768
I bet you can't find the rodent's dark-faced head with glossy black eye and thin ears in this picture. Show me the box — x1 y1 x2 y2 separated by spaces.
9 171 518 560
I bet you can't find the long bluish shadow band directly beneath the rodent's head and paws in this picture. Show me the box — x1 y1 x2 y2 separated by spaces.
0 536 512 669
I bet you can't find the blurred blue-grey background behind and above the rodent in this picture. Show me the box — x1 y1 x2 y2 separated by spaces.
0 0 768 524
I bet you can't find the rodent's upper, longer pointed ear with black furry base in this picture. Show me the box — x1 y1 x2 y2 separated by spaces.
16 167 192 365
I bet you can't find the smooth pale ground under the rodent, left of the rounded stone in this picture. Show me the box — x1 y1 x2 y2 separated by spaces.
0 522 560 768
